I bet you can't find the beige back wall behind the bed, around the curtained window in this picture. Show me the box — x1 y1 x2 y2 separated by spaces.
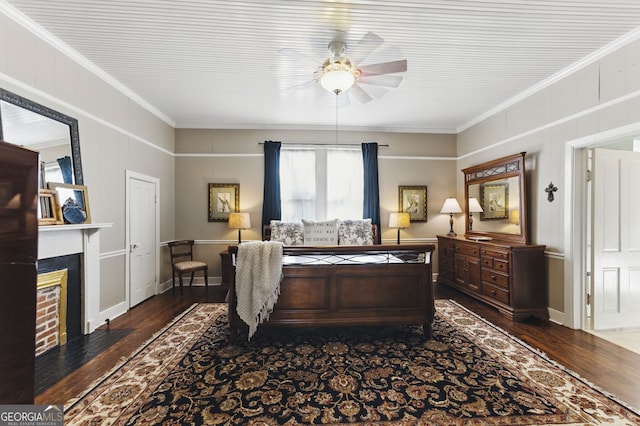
176 129 458 276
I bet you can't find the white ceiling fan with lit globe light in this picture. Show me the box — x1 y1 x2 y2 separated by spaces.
279 32 407 105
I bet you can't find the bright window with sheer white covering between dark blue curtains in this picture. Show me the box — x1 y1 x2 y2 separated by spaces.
280 148 364 222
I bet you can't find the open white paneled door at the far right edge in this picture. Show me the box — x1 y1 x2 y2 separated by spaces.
591 149 640 330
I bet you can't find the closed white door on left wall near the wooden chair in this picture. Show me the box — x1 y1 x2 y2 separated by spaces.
127 173 159 307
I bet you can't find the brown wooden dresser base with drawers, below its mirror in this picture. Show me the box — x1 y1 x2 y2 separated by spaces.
438 236 549 321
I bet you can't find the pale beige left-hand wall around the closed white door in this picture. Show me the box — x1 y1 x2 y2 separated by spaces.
0 10 175 317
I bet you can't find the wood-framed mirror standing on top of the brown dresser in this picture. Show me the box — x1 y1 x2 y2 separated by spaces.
462 152 529 244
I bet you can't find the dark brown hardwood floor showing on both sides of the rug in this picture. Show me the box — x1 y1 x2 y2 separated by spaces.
35 284 640 409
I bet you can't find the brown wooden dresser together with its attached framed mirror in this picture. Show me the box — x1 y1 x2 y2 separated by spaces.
438 152 549 321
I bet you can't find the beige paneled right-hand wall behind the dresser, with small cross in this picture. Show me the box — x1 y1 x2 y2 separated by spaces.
457 41 640 324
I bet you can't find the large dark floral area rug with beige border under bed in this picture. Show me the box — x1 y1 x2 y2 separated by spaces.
65 300 640 425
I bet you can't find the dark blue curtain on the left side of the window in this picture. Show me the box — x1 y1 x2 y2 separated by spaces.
262 141 282 230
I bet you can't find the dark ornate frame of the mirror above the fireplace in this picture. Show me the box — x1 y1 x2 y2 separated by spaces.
0 88 84 185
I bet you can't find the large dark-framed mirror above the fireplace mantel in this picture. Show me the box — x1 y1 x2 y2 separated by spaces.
0 89 84 185
